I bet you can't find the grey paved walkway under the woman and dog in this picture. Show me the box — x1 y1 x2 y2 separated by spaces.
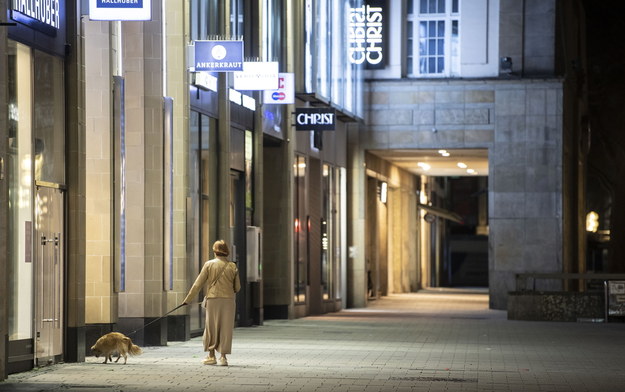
0 290 625 392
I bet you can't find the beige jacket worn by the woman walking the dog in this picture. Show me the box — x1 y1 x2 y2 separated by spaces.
183 256 241 304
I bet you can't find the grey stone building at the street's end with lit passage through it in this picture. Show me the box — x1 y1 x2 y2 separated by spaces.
348 0 586 309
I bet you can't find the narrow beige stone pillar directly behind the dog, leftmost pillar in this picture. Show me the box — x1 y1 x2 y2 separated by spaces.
82 20 118 355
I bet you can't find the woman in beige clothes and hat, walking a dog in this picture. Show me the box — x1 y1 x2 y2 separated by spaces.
182 240 241 366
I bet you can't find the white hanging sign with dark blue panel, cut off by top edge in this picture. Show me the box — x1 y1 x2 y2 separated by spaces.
89 0 152 20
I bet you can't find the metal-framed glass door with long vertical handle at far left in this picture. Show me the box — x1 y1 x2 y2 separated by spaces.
35 186 65 366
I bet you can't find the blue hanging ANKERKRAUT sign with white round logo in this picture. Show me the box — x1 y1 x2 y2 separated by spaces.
194 41 243 72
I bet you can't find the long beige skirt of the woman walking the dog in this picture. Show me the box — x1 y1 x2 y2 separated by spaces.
203 298 236 354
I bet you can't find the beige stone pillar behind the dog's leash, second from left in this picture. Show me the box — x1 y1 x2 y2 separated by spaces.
119 0 167 346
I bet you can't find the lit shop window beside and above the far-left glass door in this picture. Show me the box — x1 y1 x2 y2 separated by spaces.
7 41 65 340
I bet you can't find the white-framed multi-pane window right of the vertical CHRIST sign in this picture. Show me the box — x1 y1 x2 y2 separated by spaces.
406 0 460 77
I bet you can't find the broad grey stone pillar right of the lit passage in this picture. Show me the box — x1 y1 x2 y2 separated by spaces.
489 81 563 309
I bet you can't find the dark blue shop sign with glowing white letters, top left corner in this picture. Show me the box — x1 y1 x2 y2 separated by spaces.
11 0 64 36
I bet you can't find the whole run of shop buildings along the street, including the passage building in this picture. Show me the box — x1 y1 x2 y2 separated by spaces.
0 0 586 377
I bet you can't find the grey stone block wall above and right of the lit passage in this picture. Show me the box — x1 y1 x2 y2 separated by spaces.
359 79 562 309
